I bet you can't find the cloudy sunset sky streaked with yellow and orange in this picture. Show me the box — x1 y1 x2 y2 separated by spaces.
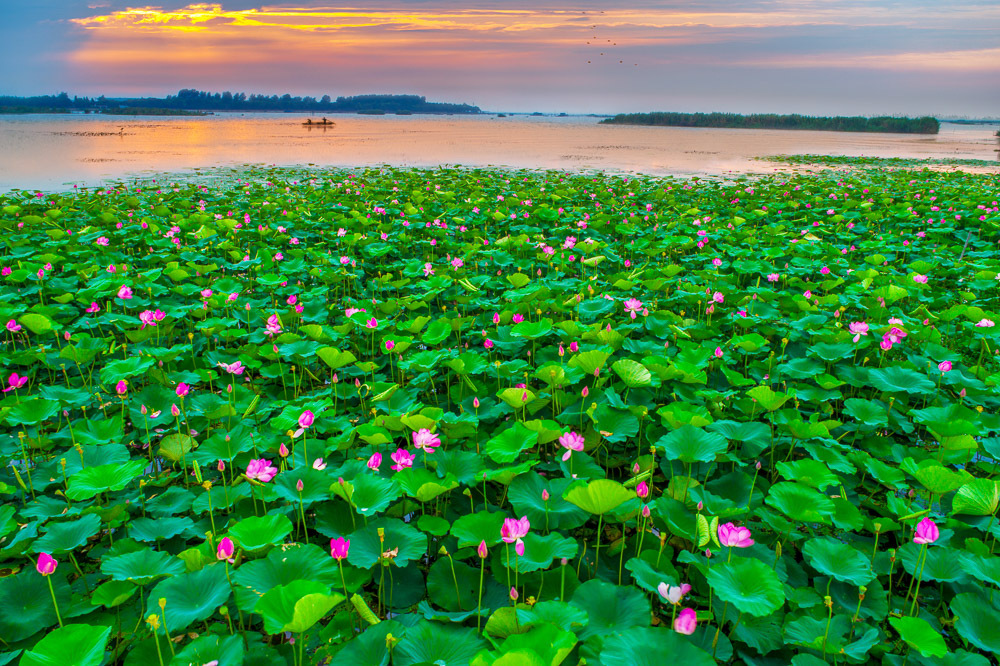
0 0 1000 117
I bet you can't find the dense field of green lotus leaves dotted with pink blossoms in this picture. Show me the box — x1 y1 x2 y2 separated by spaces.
0 162 1000 666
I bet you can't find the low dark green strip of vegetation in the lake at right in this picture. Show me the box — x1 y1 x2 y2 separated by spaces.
601 111 939 134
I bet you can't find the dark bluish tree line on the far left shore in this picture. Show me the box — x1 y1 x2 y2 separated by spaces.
0 88 481 114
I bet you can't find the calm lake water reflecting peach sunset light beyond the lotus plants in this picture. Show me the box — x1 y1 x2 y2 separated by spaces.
0 113 1000 192
